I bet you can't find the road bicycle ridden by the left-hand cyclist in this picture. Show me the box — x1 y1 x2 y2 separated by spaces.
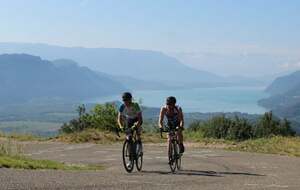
122 125 143 173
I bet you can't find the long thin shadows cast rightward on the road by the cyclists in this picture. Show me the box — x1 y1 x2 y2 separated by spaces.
142 170 265 177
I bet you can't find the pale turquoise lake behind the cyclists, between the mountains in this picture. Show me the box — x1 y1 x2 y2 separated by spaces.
92 87 268 114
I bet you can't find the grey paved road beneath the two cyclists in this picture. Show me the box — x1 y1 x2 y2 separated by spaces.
0 143 300 190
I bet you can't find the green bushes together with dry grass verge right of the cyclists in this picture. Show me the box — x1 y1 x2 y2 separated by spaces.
185 112 300 156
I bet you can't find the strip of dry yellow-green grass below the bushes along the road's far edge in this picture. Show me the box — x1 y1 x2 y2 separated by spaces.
0 129 300 157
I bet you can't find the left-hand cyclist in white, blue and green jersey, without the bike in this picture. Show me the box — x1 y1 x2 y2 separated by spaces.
118 92 143 147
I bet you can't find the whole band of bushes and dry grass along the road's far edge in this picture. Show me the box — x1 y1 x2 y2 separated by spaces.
0 104 300 156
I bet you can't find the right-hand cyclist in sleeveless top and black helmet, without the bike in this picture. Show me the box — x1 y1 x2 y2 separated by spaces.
158 96 184 153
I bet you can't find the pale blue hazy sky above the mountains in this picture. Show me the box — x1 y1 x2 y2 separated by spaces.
0 0 300 76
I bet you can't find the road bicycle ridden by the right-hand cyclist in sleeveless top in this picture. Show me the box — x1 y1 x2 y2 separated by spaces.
160 126 182 173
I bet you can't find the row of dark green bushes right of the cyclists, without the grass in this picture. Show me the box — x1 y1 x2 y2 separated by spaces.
188 112 295 141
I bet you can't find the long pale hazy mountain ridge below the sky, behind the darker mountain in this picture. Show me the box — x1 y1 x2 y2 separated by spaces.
0 43 239 87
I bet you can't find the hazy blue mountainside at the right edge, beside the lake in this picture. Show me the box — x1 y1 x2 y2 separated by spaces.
259 71 300 121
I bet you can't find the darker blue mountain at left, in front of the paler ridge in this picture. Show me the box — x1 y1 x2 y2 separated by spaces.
0 54 125 104
